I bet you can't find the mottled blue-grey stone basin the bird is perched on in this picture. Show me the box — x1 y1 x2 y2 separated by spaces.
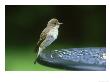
37 47 106 71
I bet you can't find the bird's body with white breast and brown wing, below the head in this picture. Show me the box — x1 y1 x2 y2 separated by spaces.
37 25 59 55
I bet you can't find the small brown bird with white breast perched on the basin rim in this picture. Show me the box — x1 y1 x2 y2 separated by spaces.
34 18 63 64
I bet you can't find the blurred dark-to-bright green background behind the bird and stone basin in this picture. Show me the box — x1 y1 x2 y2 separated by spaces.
5 5 106 71
